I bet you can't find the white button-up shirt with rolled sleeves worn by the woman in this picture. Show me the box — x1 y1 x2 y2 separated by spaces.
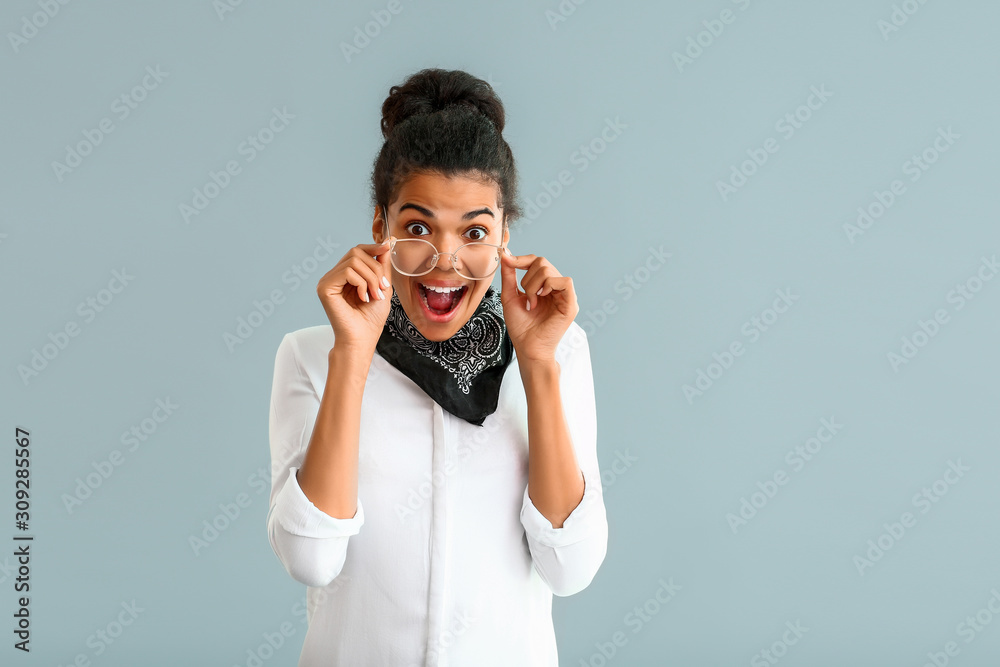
267 322 608 667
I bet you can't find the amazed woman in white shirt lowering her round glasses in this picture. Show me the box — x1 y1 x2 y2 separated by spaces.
267 69 608 667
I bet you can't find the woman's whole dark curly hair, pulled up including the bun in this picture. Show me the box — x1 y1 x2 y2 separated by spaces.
371 68 521 223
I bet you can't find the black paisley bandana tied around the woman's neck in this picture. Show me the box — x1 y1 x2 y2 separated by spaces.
375 285 514 426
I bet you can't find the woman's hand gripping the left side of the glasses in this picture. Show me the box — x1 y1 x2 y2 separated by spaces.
316 237 392 353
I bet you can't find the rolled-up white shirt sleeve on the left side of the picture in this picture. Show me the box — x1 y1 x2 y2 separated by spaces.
267 334 364 586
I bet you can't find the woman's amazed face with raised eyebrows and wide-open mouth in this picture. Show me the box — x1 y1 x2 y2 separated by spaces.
372 173 510 341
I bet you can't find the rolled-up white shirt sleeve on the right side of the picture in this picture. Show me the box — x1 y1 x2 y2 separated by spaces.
521 322 608 597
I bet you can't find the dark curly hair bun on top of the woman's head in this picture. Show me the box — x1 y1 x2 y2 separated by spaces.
382 68 504 139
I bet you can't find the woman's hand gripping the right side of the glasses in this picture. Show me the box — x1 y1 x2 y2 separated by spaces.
500 253 580 363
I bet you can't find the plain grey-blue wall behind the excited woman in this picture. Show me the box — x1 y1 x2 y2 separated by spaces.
0 0 1000 666
